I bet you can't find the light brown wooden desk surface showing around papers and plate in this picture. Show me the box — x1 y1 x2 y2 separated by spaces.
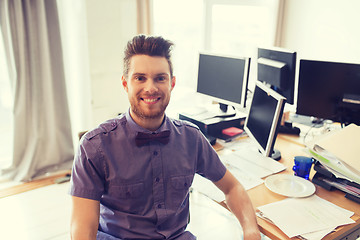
222 134 360 240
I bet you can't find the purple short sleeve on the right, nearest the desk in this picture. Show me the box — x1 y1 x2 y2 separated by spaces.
196 132 226 182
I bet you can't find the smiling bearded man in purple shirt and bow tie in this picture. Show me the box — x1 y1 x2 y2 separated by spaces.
70 35 260 240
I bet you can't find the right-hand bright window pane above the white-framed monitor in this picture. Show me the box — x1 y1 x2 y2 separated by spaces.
205 1 274 55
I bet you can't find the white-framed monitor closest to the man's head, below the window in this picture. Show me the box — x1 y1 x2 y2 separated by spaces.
197 53 250 116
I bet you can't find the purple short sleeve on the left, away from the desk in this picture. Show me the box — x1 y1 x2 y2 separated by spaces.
69 138 105 201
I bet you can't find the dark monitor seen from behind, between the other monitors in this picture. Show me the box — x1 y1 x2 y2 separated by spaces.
257 48 296 104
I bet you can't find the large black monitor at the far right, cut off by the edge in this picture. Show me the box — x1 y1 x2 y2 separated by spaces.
296 59 360 124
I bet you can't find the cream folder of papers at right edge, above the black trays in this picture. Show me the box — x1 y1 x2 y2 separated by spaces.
308 124 360 184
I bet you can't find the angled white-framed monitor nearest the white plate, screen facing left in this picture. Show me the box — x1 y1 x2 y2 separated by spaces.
244 81 285 160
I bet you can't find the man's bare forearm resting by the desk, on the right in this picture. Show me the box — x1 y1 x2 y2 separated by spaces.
215 170 261 240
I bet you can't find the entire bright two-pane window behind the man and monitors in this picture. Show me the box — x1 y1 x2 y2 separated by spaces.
153 0 279 89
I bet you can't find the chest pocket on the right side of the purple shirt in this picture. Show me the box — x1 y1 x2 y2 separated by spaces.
170 174 194 212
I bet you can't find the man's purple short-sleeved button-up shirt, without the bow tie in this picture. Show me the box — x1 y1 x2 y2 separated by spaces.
70 109 226 239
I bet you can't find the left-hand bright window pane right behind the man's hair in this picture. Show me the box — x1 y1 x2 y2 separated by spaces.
153 0 203 90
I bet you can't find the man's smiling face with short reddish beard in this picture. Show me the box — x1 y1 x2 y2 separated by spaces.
122 55 175 120
